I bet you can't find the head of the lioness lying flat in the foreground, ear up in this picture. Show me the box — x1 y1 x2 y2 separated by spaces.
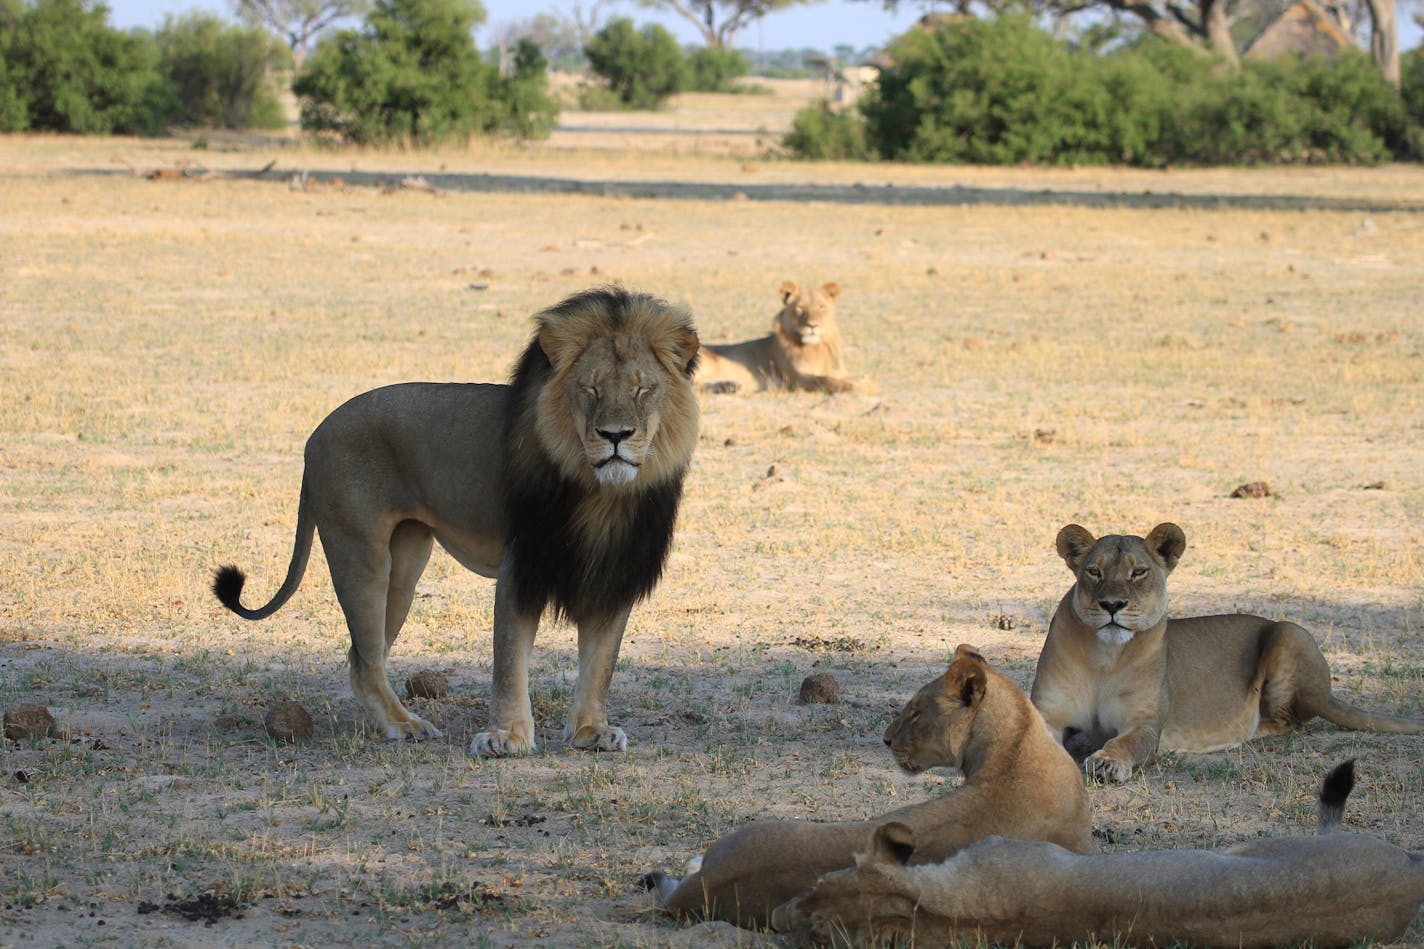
772 821 916 945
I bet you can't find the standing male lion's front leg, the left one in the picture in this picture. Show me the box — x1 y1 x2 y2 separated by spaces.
470 560 540 758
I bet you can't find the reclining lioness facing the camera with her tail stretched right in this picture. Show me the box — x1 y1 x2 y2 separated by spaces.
1031 524 1424 781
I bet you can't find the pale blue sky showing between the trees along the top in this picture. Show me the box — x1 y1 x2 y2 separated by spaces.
107 0 948 51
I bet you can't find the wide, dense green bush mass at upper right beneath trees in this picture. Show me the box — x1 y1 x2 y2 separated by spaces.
786 16 1424 167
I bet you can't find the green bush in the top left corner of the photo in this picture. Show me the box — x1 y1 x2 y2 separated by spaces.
0 0 177 134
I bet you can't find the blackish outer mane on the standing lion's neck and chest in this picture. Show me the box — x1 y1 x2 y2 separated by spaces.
504 288 682 623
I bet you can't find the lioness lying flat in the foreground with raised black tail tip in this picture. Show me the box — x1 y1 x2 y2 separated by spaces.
772 762 1424 949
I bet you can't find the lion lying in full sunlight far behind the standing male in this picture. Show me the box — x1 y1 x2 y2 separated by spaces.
696 281 876 395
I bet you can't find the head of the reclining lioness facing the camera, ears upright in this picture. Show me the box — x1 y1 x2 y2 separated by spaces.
1057 523 1186 644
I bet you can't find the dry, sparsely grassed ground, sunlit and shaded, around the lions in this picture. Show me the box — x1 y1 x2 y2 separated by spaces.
8 85 1424 946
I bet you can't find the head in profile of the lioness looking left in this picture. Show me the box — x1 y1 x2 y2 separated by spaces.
884 645 988 774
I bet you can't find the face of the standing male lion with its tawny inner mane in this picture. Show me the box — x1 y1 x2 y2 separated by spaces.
535 289 698 487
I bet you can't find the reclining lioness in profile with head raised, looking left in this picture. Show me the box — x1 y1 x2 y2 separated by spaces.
645 645 1095 928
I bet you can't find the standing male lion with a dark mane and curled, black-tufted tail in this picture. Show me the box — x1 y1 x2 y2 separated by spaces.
214 288 698 755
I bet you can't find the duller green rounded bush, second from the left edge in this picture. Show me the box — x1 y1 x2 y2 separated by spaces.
158 13 290 128
